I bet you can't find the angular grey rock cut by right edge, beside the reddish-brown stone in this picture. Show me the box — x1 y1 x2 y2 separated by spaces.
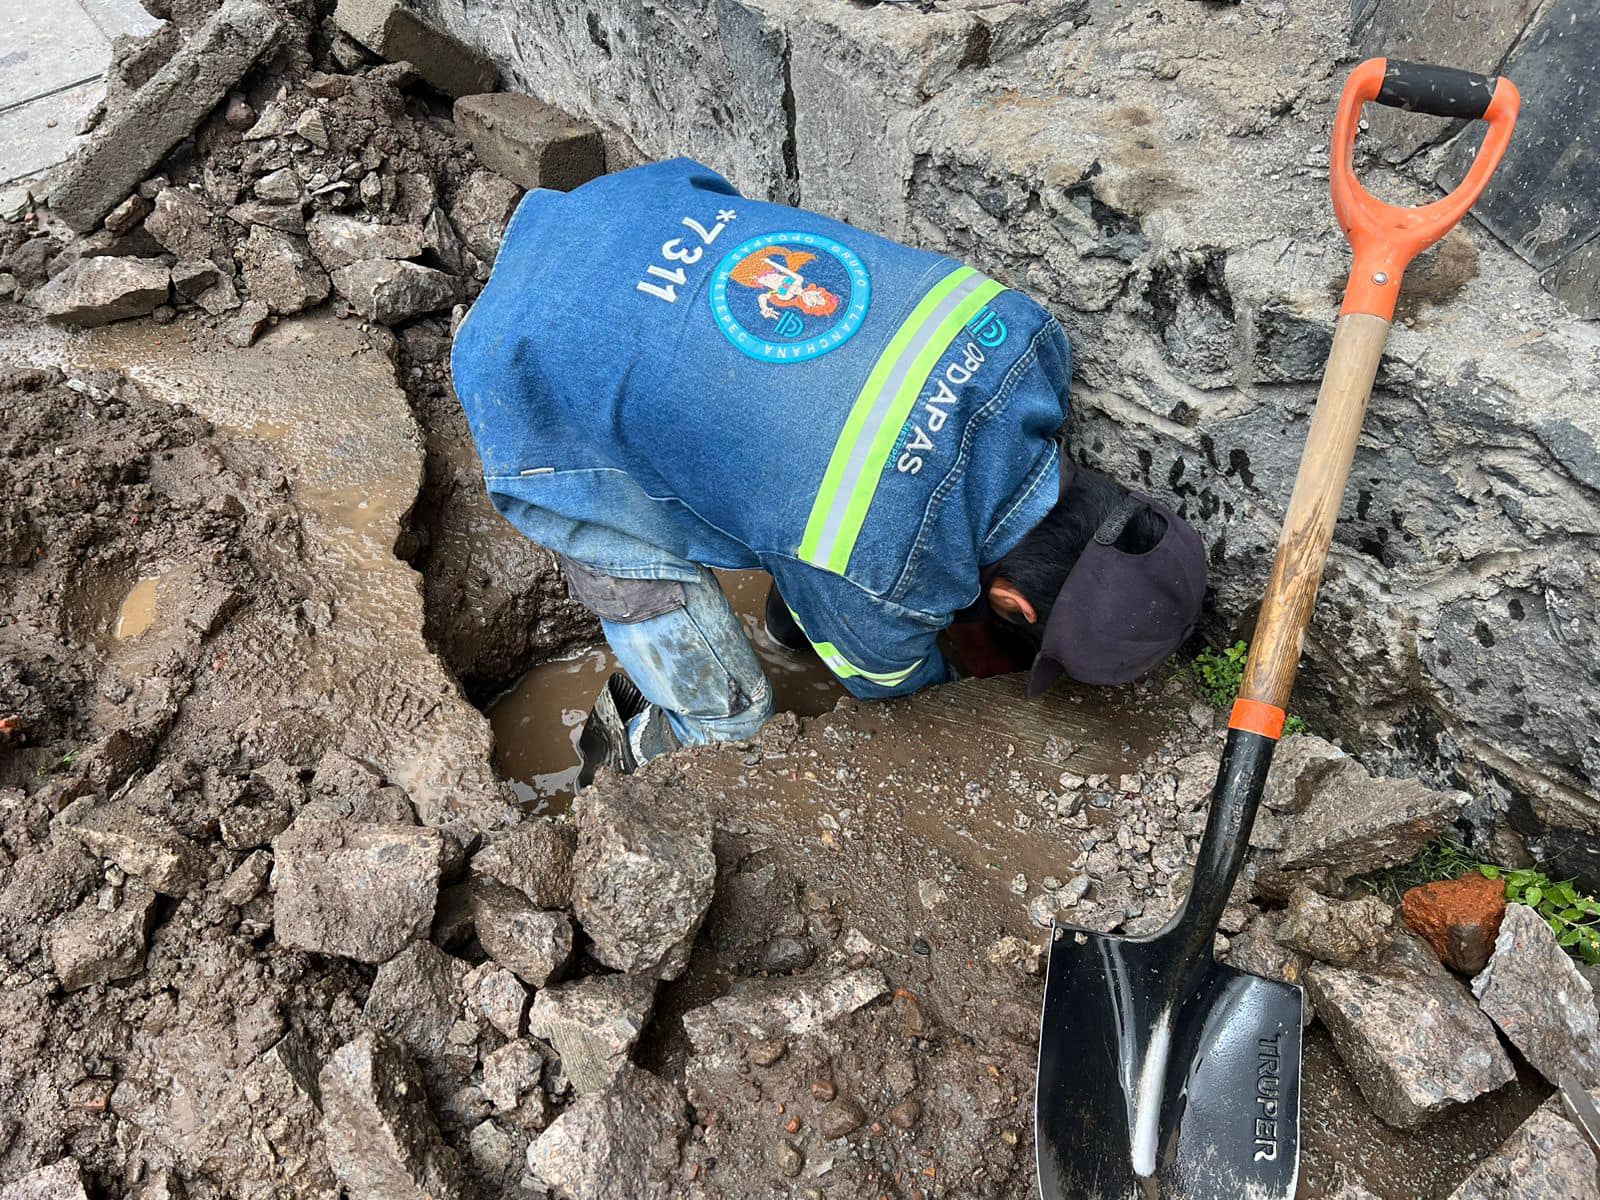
1472 904 1600 1088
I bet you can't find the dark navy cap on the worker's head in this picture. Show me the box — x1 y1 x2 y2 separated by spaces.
1027 493 1205 696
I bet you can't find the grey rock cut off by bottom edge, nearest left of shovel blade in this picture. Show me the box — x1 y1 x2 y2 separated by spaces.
528 1064 688 1200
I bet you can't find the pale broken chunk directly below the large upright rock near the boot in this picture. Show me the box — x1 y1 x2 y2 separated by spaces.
528 974 656 1096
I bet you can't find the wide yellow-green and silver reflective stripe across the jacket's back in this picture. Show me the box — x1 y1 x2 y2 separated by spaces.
800 267 1003 574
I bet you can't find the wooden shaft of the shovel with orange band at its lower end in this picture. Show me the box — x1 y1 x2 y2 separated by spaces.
1235 312 1389 720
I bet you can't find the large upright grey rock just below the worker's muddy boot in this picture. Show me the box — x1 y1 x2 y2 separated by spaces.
573 776 717 979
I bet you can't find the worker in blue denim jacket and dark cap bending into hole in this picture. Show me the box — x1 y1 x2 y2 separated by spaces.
451 158 1205 779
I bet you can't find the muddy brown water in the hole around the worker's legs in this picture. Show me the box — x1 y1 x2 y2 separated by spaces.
490 571 845 813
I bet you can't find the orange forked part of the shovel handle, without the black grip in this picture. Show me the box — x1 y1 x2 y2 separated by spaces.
1328 58 1522 320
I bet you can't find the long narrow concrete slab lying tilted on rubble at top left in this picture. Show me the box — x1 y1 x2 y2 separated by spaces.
50 0 283 234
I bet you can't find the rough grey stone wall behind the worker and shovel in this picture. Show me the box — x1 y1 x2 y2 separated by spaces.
422 0 1600 869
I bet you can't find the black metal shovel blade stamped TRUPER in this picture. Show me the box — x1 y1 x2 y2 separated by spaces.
1035 926 1301 1200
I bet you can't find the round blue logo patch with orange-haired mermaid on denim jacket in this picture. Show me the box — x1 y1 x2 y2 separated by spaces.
710 232 872 363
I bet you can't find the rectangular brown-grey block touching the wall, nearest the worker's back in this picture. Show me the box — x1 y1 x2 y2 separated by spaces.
456 91 605 192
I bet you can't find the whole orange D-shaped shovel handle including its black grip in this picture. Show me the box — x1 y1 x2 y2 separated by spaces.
1328 58 1522 320
